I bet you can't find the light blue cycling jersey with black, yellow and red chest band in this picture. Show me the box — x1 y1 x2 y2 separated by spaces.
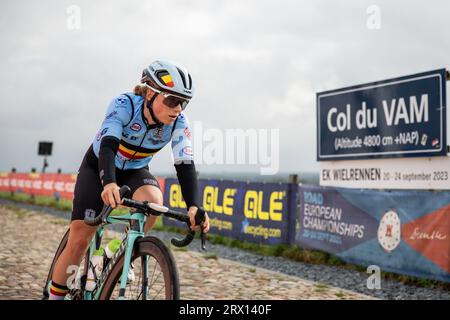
92 93 194 170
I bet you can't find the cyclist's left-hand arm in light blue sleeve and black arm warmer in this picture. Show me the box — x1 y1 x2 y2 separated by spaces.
98 95 131 186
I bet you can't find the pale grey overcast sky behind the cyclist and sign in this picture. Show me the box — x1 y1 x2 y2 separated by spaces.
0 0 450 174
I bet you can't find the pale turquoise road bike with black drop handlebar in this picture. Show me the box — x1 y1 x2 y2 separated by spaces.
43 186 206 300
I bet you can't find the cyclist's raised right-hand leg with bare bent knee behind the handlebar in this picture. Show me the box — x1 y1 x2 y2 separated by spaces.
118 168 163 232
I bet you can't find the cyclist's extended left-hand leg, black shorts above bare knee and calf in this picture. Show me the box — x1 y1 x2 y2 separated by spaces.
52 151 103 298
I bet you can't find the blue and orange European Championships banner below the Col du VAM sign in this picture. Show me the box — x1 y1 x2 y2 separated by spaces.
295 185 450 282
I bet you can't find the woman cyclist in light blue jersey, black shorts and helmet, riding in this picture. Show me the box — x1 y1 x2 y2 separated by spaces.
50 60 209 300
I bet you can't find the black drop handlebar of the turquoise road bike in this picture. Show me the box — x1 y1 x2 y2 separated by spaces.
84 186 206 250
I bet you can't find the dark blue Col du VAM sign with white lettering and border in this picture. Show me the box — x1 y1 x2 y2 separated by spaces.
317 69 447 161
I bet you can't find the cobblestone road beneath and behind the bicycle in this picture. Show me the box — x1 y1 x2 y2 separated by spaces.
0 206 372 300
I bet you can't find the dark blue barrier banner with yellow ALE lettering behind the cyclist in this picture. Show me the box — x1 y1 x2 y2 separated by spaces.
164 179 298 244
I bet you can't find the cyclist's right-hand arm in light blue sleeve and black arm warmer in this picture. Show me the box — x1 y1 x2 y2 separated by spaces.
172 114 200 208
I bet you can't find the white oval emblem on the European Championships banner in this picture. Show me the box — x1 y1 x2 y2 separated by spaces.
378 210 401 252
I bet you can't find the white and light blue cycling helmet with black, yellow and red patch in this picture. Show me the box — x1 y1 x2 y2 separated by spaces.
141 60 194 101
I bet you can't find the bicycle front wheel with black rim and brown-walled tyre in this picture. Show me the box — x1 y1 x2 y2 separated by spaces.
99 237 180 300
